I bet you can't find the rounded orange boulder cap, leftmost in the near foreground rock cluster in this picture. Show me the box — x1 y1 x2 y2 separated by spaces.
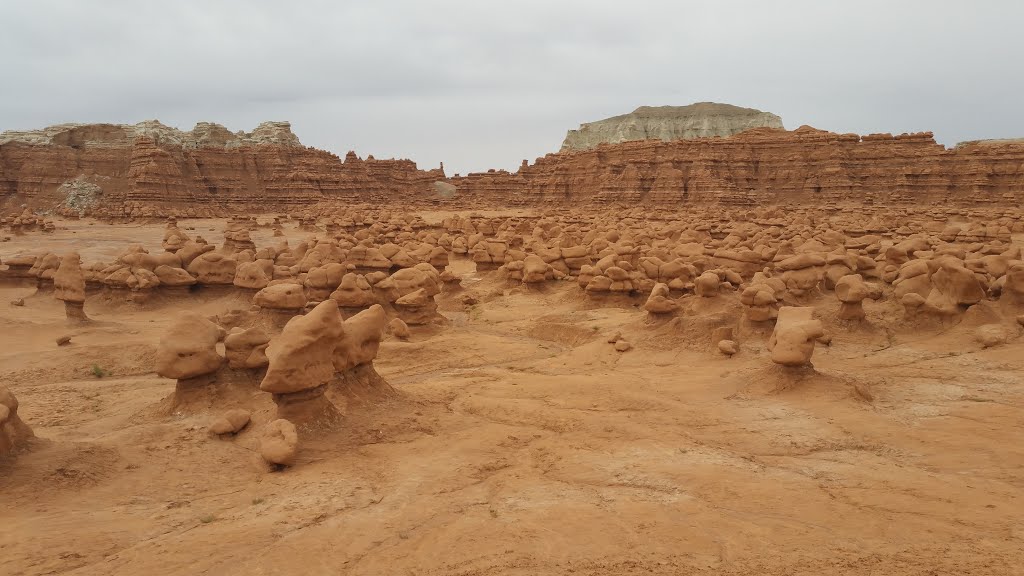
157 312 224 380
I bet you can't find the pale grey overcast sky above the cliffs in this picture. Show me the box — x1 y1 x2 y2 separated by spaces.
0 0 1024 174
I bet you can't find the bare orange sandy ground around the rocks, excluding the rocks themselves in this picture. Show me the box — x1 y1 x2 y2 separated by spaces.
0 217 1024 576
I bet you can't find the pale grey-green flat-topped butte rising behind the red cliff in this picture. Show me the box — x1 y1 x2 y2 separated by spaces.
562 102 782 151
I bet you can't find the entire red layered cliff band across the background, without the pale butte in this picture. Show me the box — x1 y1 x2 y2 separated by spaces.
0 123 1024 216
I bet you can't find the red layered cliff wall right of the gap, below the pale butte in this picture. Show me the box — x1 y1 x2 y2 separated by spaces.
449 127 1024 206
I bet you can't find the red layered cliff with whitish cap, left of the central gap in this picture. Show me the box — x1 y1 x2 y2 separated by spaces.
0 122 444 215
